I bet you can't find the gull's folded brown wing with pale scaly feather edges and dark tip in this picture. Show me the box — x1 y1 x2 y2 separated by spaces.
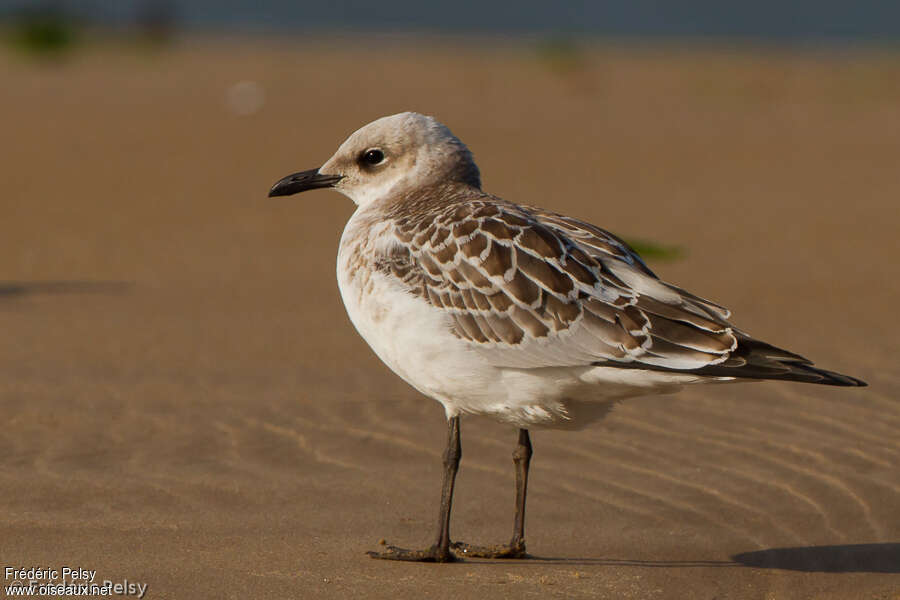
382 197 857 385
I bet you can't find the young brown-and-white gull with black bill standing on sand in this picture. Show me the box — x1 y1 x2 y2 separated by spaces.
269 112 866 562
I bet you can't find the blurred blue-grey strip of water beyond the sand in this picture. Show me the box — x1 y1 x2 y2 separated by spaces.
4 0 900 36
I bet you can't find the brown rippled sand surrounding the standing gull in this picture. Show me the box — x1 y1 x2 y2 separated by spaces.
0 37 900 599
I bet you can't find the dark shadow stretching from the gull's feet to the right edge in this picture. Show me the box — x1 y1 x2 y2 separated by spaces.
474 543 900 573
